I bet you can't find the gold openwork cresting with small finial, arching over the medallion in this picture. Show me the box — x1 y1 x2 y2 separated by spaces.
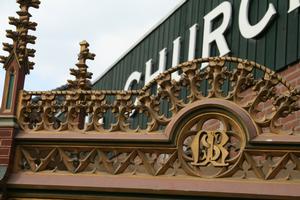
19 56 300 134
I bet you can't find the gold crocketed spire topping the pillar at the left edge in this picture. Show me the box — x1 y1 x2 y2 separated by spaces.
0 0 40 74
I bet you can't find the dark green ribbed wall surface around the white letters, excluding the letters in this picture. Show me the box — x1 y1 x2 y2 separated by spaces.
94 0 300 89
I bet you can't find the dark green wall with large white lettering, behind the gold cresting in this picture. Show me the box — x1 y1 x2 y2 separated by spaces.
93 0 300 90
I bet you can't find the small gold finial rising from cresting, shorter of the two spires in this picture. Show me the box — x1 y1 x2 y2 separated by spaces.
68 40 96 90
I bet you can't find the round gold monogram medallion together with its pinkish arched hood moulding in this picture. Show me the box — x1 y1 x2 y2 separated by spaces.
166 99 258 178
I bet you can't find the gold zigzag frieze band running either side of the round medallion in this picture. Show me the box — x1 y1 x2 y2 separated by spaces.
15 145 300 182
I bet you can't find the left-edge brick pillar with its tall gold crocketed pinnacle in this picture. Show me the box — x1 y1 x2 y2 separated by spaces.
0 0 40 198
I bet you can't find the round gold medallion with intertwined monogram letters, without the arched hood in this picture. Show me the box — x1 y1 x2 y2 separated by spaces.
178 108 246 177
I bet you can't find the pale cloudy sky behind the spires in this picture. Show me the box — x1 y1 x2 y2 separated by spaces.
0 0 182 101
